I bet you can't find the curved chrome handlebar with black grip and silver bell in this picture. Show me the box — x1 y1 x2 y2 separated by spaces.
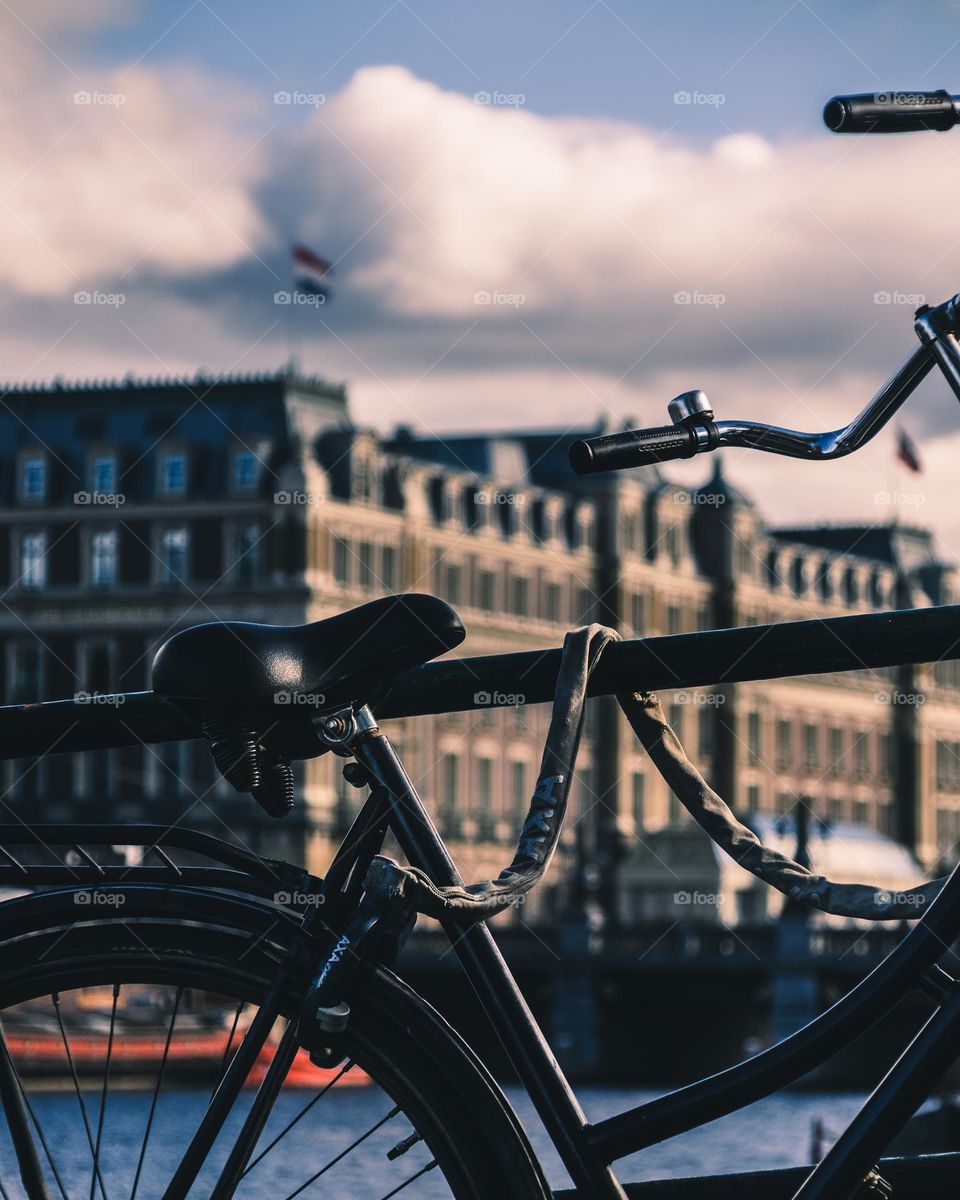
570 295 960 475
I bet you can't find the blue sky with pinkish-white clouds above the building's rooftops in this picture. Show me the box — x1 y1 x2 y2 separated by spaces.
0 0 960 549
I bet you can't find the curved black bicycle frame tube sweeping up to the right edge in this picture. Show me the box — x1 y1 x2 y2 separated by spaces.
588 866 960 1162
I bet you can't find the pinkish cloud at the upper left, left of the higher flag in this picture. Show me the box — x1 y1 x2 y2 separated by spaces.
0 0 270 298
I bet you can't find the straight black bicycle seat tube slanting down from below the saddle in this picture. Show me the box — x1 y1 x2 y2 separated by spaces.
355 732 626 1200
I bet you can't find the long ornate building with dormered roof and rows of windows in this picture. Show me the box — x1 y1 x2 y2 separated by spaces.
0 371 960 916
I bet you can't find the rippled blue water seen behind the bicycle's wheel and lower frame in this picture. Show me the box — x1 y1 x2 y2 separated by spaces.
0 1086 864 1200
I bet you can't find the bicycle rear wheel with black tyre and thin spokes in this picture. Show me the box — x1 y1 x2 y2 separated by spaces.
0 889 550 1200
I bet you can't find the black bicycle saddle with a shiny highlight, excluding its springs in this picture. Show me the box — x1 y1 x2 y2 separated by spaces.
151 593 466 716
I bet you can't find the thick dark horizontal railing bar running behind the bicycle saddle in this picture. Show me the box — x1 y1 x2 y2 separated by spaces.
0 605 960 760
